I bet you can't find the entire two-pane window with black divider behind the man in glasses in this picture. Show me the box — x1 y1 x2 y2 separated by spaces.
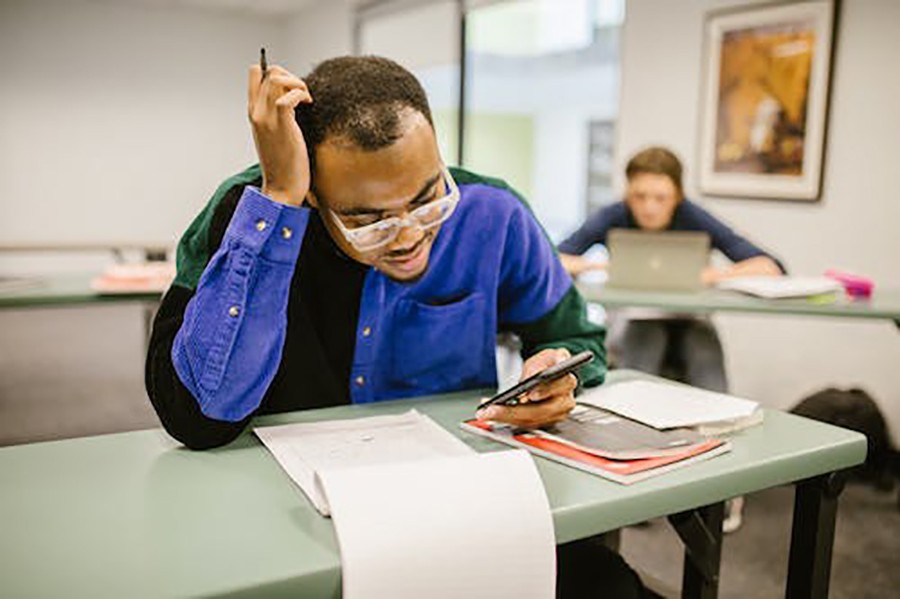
356 0 625 242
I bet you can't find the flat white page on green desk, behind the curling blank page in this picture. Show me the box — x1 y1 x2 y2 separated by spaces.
253 410 475 516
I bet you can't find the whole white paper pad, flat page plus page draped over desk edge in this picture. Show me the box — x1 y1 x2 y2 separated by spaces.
255 410 556 599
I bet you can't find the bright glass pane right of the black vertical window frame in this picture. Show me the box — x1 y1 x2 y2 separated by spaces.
463 0 625 241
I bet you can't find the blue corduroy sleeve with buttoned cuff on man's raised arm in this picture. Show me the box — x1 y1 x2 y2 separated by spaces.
172 186 309 422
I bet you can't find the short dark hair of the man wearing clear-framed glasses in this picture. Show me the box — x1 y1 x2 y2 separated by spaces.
296 56 433 170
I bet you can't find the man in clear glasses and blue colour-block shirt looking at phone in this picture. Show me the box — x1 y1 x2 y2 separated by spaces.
146 57 605 449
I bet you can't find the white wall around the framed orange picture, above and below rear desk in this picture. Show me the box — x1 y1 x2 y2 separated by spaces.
617 0 900 440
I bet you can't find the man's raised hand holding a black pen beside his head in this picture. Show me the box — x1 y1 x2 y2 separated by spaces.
247 50 313 206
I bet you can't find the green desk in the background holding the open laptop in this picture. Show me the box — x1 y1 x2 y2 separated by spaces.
577 282 900 321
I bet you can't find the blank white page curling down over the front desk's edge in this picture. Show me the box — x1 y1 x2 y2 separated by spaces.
321 450 556 599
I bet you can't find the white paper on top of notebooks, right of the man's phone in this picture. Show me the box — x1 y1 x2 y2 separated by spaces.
578 381 759 429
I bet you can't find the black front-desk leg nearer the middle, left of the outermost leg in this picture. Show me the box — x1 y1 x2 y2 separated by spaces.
669 502 725 599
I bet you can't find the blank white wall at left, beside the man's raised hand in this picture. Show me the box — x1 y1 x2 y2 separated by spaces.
0 0 284 264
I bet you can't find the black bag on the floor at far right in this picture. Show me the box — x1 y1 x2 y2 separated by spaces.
791 387 900 491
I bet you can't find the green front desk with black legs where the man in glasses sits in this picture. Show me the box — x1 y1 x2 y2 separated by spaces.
0 371 866 598
